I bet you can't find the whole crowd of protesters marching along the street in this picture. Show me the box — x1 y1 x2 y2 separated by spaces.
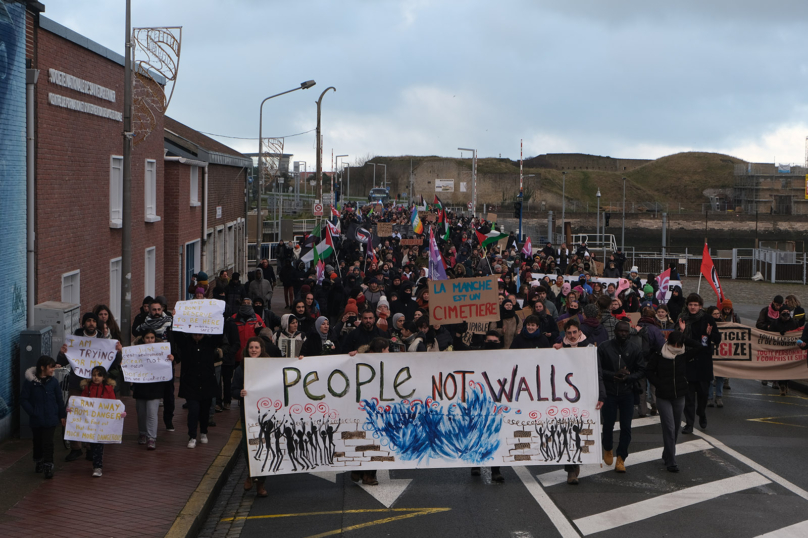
22 199 808 488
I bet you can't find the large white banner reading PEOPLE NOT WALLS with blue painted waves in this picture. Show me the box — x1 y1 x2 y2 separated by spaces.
244 347 601 476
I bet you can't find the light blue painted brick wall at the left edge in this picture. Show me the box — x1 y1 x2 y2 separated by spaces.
0 3 27 439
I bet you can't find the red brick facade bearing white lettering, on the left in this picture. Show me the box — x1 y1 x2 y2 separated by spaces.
35 28 166 322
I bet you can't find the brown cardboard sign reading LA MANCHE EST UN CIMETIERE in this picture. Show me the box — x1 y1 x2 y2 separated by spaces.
429 275 499 325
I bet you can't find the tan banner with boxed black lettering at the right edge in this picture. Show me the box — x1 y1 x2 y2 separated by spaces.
713 323 808 381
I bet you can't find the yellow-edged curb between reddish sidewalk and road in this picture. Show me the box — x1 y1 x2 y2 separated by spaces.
165 421 241 538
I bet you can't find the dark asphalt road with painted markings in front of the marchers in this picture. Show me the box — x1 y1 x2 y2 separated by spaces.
200 376 808 538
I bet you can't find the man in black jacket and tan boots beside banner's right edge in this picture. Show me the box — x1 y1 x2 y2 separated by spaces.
598 321 646 473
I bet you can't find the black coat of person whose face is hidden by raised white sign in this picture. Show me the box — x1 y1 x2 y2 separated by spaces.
171 333 221 400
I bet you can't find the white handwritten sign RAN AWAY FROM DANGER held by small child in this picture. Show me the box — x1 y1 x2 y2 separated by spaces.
65 396 125 444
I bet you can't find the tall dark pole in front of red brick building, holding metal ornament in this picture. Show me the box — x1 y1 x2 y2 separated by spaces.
121 0 133 346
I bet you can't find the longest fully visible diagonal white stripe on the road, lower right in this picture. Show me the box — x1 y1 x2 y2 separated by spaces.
573 473 770 536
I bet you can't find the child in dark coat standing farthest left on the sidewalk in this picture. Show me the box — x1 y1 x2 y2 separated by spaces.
20 355 66 478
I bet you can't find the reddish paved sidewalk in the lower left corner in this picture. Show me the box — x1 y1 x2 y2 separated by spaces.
0 378 241 538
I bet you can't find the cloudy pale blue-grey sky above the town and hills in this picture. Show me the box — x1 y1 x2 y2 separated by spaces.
43 0 808 166
